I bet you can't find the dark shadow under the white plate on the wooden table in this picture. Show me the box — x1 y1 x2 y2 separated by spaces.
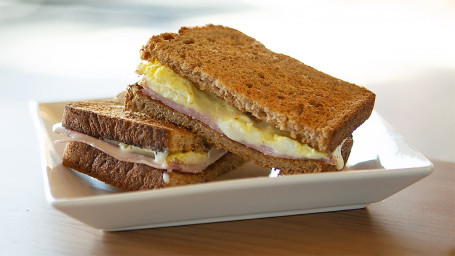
93 209 400 255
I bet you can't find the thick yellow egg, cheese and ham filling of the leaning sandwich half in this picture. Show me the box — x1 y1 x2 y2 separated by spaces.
137 61 344 170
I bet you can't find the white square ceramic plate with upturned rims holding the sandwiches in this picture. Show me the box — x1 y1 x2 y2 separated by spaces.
30 99 433 231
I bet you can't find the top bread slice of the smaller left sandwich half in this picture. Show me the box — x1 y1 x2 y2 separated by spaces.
62 100 210 152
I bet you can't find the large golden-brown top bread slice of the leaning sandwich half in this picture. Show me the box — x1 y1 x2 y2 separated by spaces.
141 25 375 152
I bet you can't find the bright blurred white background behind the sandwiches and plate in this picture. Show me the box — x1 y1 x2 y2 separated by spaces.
0 0 455 162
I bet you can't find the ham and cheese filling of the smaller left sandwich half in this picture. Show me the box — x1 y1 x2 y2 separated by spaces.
52 123 227 173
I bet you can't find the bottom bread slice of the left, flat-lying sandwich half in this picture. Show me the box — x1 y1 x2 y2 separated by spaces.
63 142 243 191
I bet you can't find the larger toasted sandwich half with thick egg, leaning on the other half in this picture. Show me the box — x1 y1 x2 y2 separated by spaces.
125 25 375 174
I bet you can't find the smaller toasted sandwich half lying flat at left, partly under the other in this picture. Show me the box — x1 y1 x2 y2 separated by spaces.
54 100 243 191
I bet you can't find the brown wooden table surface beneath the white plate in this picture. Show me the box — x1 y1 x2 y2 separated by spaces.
0 161 455 255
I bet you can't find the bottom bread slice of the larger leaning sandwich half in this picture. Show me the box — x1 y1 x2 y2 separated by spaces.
125 84 353 174
